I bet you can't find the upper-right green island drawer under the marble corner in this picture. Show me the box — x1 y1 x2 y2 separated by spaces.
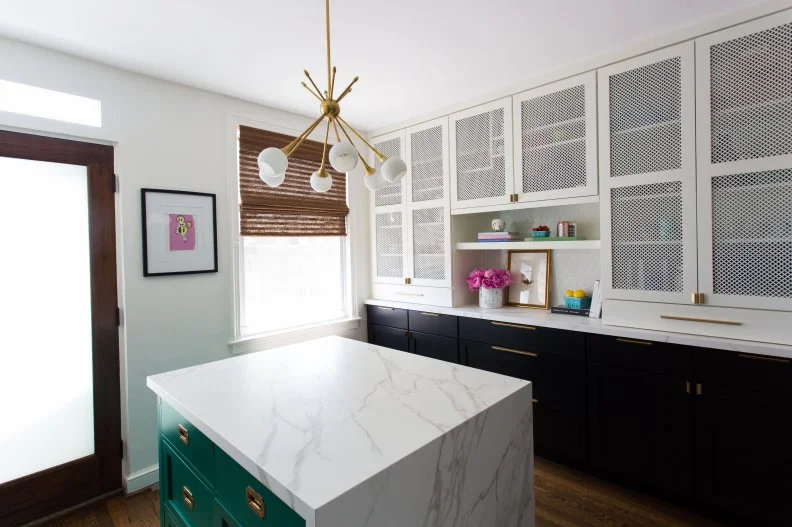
215 448 305 527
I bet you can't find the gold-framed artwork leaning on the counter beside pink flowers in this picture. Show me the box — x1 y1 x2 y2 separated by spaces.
506 250 550 309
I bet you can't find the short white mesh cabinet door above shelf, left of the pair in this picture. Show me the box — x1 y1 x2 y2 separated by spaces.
449 97 514 210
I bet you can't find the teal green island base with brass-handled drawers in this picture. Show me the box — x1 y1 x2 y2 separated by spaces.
157 400 305 527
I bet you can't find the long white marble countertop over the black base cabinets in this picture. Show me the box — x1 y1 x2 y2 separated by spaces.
365 299 792 358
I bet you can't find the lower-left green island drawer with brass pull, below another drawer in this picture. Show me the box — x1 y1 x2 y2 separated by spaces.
161 442 214 527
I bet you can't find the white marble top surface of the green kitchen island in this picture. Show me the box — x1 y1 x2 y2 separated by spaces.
147 337 530 526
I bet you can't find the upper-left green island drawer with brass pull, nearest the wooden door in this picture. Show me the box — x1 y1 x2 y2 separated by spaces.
159 400 214 484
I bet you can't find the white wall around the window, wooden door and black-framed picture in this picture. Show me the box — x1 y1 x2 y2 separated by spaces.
0 38 369 484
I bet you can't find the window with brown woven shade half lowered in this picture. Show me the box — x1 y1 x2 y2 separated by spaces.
238 126 350 337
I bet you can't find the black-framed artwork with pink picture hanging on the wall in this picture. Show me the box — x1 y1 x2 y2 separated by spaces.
140 188 217 276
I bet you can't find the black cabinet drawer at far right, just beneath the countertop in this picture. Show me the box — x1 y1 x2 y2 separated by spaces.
696 348 792 394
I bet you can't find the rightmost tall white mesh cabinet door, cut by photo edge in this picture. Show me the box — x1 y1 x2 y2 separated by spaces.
696 11 792 311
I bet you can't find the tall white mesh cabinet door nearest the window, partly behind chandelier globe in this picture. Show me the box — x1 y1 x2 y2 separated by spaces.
370 130 409 284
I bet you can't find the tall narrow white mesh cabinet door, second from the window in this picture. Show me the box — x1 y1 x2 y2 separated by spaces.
405 117 451 287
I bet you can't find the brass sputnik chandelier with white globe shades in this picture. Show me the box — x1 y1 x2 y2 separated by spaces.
258 0 407 192
